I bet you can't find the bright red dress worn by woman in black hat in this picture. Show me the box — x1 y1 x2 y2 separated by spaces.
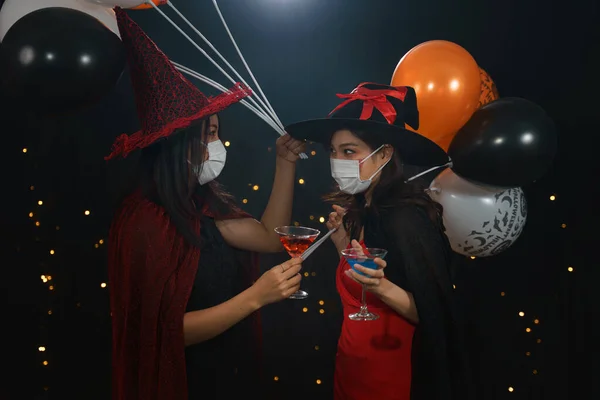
334 242 415 400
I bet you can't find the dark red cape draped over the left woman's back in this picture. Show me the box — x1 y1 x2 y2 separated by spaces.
108 193 259 400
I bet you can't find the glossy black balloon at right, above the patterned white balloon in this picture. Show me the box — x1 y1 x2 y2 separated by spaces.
448 98 557 187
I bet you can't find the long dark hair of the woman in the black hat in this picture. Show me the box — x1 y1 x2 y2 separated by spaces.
325 129 443 238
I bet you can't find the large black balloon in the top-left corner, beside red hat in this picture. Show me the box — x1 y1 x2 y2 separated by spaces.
1 7 125 113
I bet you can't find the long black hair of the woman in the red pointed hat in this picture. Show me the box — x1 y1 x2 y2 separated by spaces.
138 114 237 247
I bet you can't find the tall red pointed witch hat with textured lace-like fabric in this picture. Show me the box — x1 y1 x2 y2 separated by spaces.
105 7 252 160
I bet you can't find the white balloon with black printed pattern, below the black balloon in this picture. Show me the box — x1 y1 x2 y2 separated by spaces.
429 169 527 257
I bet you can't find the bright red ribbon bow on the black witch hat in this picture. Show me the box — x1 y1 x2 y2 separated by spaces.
329 83 408 124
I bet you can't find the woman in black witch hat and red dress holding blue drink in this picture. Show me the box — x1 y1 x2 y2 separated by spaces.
287 83 470 400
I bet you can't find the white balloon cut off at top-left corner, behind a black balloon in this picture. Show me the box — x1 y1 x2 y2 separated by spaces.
0 0 121 42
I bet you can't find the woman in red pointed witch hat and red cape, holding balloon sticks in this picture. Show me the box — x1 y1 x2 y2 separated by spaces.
107 8 303 400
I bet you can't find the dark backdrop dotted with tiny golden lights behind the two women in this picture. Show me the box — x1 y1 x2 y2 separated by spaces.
0 0 600 400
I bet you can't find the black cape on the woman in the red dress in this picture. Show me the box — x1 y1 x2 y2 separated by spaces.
362 204 476 400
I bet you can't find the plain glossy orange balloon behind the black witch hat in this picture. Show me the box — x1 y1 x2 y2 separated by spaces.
391 40 481 150
